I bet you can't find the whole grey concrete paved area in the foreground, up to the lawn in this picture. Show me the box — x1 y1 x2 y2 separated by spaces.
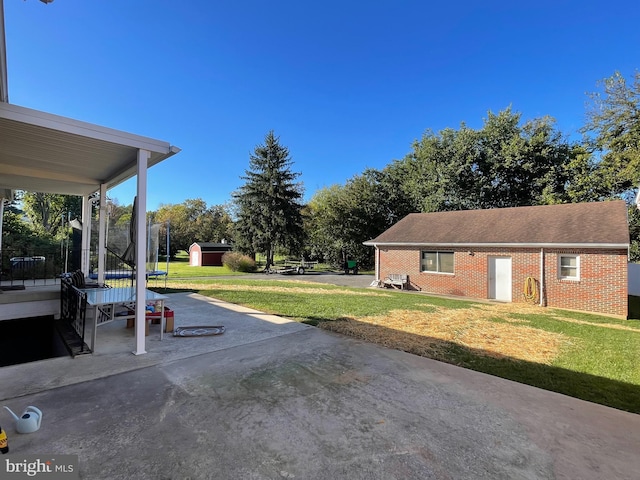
0 294 640 480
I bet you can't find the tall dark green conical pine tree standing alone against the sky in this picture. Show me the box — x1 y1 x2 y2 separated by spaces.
233 130 304 266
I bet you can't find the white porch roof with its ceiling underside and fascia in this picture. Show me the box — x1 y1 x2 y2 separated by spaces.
0 102 180 195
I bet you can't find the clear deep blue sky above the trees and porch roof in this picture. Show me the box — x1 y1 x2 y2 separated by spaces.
4 0 640 210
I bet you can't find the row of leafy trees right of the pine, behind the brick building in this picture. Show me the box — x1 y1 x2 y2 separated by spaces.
298 72 640 265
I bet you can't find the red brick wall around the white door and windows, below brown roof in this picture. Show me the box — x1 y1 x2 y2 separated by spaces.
379 247 628 317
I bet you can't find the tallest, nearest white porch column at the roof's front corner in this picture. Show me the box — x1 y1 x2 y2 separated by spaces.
133 149 151 355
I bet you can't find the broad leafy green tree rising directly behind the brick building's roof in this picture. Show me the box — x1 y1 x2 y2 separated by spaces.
382 108 573 216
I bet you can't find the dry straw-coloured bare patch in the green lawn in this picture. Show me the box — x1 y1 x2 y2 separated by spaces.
319 304 571 364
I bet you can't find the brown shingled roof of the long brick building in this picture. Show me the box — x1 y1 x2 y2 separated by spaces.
365 200 629 247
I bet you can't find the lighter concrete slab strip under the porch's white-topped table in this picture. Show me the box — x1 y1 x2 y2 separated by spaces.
0 293 312 398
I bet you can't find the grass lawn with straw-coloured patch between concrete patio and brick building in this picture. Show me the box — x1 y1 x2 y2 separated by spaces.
154 278 640 413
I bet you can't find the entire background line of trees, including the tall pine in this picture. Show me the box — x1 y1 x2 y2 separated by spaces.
5 72 640 267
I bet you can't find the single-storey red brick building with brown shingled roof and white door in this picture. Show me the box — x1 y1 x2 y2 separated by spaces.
365 200 629 318
